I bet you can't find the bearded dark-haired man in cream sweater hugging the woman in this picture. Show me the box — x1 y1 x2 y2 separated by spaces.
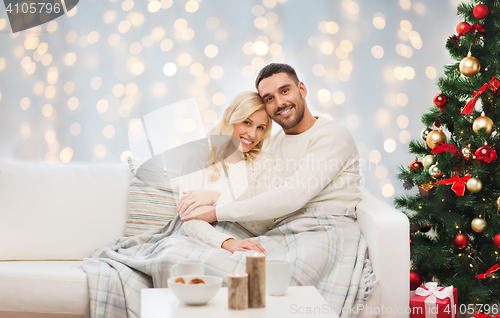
179 63 361 223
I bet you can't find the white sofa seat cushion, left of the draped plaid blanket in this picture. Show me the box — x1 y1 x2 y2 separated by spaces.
0 261 89 316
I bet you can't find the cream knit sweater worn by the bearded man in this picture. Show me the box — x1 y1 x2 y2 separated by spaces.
216 117 362 222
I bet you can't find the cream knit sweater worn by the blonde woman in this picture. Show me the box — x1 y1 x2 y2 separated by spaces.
179 152 276 247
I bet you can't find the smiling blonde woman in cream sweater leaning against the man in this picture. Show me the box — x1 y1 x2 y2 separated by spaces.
178 92 275 253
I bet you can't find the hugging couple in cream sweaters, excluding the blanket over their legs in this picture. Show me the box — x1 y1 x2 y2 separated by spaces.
178 63 361 253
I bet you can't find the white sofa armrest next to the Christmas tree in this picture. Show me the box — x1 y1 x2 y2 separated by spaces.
356 189 410 317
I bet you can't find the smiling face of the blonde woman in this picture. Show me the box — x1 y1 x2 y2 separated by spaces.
233 109 269 152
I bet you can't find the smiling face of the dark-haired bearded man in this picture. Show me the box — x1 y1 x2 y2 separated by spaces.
258 72 307 130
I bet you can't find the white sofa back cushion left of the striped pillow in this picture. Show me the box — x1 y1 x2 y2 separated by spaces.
0 159 131 260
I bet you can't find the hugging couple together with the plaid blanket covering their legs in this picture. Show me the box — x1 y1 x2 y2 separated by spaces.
83 64 376 317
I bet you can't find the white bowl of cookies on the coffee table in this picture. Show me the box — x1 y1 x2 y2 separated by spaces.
167 275 222 305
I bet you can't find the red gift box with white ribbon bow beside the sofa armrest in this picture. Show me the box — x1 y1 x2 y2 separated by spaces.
410 282 457 318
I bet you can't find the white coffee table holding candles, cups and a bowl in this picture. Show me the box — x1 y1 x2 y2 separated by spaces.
141 286 338 318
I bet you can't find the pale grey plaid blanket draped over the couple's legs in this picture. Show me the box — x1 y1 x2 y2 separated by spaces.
83 207 375 318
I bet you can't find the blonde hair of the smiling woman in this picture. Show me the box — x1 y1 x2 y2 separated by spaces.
209 91 272 181
